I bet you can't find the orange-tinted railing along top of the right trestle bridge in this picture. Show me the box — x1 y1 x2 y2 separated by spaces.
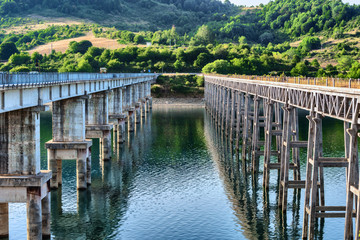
207 74 360 89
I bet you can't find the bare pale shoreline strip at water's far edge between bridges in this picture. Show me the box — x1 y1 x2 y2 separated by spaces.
153 98 205 107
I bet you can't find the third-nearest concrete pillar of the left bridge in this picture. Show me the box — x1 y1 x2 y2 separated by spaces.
85 92 112 161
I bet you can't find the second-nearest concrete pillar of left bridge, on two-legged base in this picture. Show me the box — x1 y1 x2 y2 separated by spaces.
45 97 92 189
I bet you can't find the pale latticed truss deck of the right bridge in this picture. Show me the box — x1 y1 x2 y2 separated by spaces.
205 75 360 122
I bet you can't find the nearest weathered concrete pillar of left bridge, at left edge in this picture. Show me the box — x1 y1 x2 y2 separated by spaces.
0 106 51 239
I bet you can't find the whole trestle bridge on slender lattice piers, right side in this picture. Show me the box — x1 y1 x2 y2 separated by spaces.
205 76 360 239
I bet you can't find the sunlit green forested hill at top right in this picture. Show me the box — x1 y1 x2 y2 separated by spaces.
210 0 360 44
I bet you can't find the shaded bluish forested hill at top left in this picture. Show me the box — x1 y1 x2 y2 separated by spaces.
0 0 236 33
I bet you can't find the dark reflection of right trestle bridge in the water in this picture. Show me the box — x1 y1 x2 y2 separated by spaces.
204 109 345 239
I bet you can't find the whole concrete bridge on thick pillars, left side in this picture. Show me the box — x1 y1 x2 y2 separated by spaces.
0 73 157 239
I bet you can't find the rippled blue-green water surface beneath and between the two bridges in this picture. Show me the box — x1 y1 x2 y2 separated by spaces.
10 108 345 240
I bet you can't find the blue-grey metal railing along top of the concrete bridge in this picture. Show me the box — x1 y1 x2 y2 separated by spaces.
0 73 155 88
